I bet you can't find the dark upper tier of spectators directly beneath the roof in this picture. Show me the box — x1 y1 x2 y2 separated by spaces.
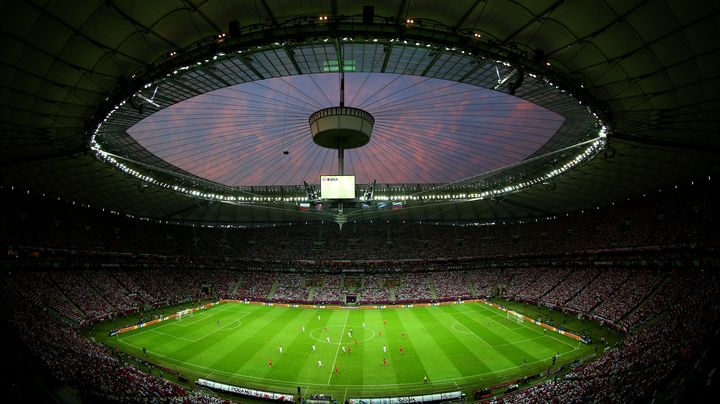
0 178 720 262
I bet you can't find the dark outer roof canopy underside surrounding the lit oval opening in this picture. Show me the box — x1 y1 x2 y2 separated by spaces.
0 0 720 223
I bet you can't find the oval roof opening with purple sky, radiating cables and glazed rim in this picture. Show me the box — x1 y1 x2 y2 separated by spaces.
96 38 600 186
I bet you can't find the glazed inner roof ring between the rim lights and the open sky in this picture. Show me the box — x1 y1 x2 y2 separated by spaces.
92 29 606 205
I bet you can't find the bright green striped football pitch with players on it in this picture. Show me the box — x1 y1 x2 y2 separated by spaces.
107 303 592 399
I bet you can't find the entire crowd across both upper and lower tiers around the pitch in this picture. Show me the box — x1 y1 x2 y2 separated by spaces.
0 181 720 402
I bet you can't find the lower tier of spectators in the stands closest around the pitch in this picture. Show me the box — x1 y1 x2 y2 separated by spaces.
2 266 718 401
